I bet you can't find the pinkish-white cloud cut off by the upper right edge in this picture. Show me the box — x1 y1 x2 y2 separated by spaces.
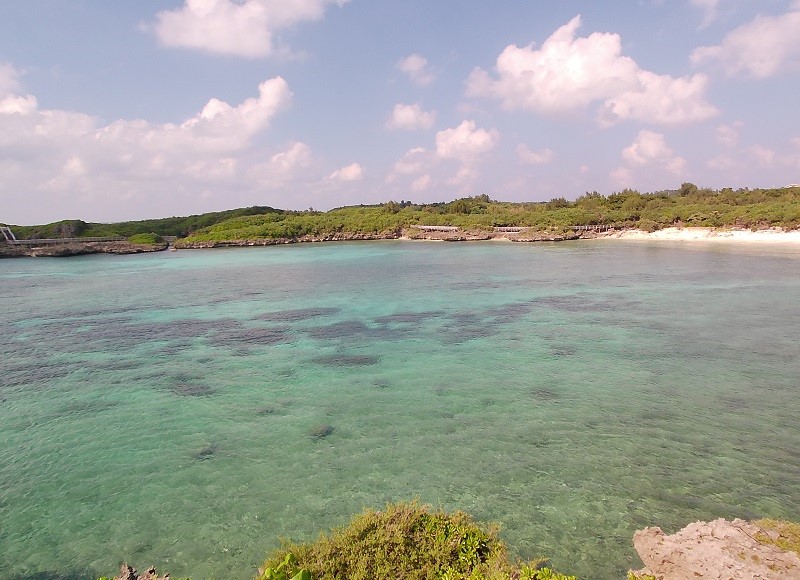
691 2 800 79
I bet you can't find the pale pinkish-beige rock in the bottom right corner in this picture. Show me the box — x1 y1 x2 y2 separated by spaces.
633 519 800 580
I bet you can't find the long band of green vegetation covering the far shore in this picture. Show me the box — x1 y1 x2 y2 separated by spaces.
11 183 800 242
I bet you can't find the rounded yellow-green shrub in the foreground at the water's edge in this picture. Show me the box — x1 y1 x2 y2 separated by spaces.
258 502 575 580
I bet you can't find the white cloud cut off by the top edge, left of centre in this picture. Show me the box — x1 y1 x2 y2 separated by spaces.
154 0 348 58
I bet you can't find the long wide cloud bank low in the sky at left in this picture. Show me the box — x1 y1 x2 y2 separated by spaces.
0 77 308 219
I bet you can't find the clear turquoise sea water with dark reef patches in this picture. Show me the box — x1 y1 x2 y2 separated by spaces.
0 242 800 580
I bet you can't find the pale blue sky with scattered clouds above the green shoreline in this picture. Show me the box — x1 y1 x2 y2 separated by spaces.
0 0 800 225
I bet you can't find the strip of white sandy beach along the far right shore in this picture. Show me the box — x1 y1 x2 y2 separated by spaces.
597 228 800 245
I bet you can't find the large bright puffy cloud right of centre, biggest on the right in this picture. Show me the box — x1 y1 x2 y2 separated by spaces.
467 16 717 126
